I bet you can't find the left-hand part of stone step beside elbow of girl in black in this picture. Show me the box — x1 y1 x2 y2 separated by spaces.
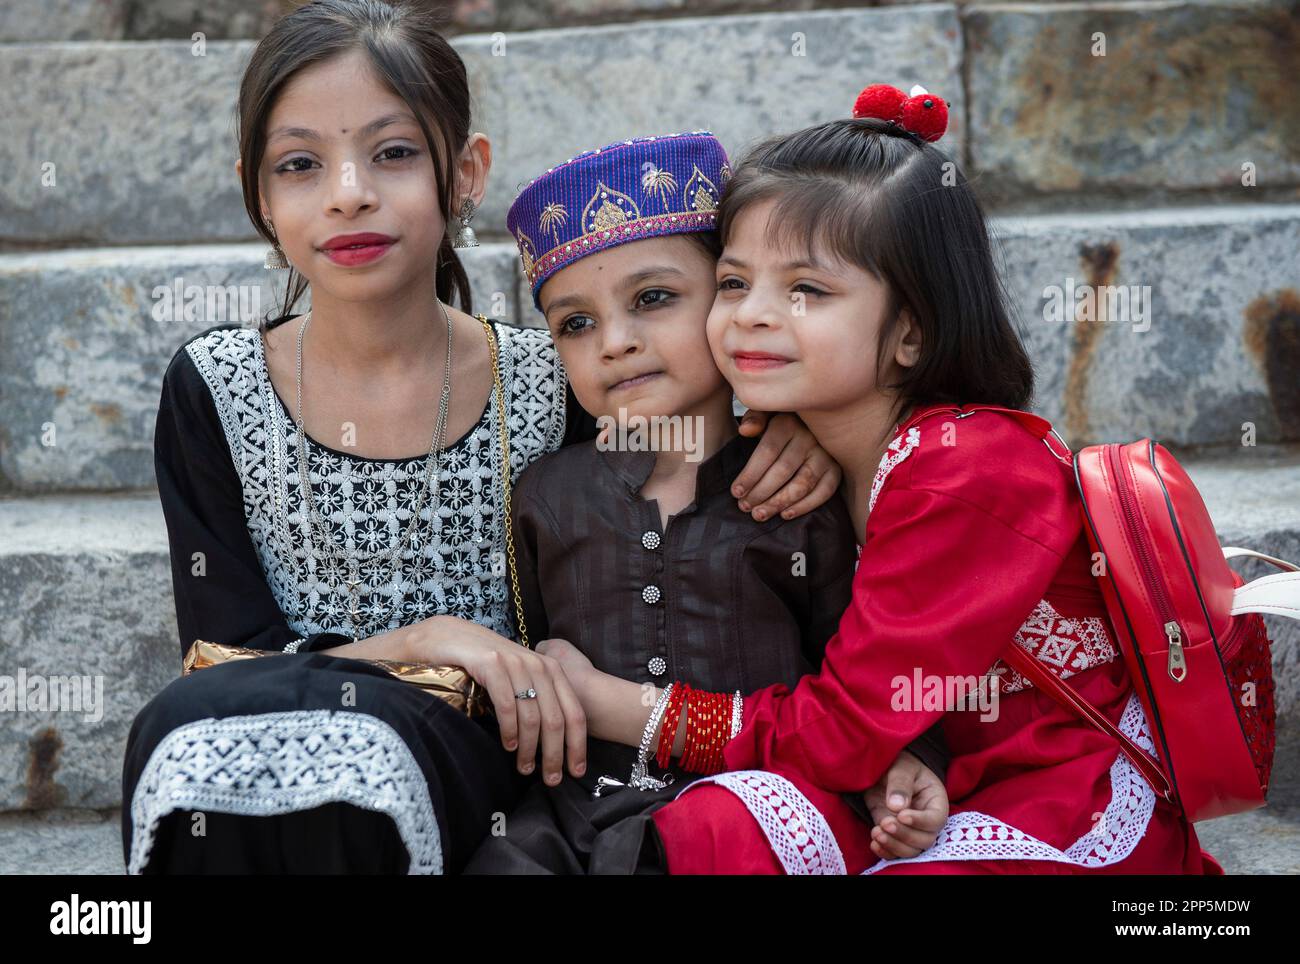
0 492 179 811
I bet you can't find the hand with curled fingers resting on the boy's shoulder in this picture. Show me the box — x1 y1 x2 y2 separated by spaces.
732 409 841 522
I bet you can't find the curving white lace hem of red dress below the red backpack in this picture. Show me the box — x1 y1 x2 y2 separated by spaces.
863 694 1156 873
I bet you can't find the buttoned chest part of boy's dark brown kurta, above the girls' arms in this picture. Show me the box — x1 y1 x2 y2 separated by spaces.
514 435 857 692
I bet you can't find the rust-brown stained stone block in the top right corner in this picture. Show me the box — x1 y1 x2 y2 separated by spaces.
962 0 1300 209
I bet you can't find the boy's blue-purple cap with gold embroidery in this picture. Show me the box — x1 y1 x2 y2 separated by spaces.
506 130 731 311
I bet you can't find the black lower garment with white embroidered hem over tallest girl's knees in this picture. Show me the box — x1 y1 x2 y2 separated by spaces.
122 652 532 874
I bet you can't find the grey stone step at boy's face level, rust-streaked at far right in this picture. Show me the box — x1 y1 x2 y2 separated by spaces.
0 205 1300 492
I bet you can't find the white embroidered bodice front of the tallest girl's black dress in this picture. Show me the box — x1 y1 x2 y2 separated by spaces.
187 325 567 644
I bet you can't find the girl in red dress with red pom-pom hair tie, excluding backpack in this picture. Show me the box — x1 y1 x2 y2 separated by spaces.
551 88 1218 873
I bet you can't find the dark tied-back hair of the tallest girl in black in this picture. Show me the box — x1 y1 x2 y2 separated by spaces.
238 0 473 330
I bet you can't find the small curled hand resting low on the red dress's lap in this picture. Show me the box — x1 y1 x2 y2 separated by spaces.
863 750 948 859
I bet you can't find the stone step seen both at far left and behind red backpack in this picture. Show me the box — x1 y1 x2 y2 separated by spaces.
0 448 1300 811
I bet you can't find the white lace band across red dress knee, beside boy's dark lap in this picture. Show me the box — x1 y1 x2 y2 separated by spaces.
677 770 846 874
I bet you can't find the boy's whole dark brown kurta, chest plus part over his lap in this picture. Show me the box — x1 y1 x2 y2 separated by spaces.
469 435 943 873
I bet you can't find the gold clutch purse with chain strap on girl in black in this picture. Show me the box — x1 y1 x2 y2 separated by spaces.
183 314 528 717
